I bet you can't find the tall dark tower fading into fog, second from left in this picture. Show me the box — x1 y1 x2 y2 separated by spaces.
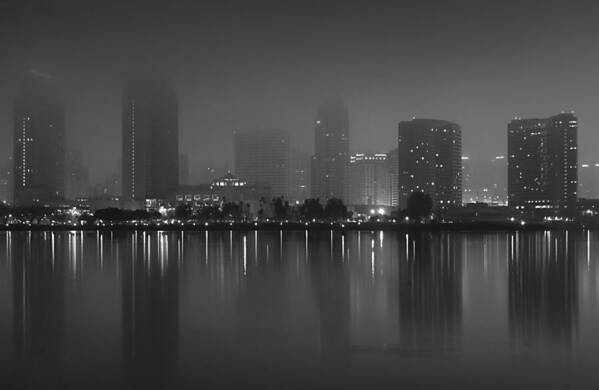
122 75 179 200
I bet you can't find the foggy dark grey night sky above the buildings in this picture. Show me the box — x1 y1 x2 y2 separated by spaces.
0 0 599 184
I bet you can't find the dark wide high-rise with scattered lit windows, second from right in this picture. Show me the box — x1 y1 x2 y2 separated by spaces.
398 119 462 208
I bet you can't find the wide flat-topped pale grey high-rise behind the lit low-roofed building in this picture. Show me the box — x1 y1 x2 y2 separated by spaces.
235 129 289 197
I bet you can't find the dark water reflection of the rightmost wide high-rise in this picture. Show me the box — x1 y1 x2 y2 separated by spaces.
509 231 579 346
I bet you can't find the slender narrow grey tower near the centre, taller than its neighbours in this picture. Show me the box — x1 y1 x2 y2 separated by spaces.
311 100 349 201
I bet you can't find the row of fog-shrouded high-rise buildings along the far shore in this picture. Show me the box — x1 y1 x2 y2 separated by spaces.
4 73 593 214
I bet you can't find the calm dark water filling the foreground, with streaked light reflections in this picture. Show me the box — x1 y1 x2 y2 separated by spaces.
0 231 599 389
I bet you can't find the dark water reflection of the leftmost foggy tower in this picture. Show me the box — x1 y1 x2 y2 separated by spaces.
10 233 67 388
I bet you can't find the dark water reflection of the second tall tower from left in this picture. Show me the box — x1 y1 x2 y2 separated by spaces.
120 232 179 388
